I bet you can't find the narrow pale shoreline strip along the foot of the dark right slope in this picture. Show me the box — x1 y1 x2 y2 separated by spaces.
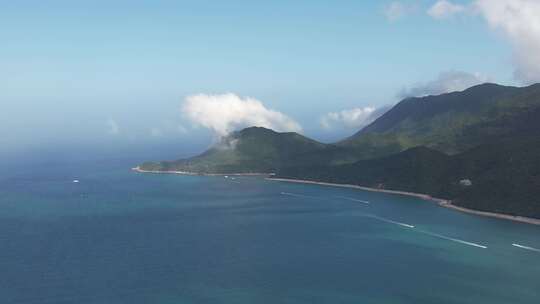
266 177 540 225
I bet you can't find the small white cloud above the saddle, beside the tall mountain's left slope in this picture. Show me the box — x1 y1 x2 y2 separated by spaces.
320 106 390 130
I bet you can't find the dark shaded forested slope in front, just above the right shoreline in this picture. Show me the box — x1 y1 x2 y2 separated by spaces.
277 134 540 218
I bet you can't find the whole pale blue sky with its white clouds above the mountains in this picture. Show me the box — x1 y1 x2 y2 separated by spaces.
0 0 540 164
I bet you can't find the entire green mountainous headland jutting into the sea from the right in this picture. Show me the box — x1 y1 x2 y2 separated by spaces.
135 83 540 222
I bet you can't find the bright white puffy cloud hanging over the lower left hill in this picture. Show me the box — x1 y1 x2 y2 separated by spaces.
182 93 302 136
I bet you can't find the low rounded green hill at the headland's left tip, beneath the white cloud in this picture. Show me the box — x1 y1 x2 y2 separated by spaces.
139 127 327 174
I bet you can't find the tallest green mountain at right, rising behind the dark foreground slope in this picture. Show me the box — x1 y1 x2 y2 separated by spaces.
336 83 540 159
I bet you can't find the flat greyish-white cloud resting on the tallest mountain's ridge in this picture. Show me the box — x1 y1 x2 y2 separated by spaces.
398 71 489 98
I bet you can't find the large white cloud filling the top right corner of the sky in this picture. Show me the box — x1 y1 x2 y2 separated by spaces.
474 0 540 84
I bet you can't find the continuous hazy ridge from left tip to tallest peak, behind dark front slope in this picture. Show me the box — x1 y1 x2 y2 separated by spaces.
140 83 540 173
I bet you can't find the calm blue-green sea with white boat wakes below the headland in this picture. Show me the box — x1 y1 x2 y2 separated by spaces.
0 160 540 304
